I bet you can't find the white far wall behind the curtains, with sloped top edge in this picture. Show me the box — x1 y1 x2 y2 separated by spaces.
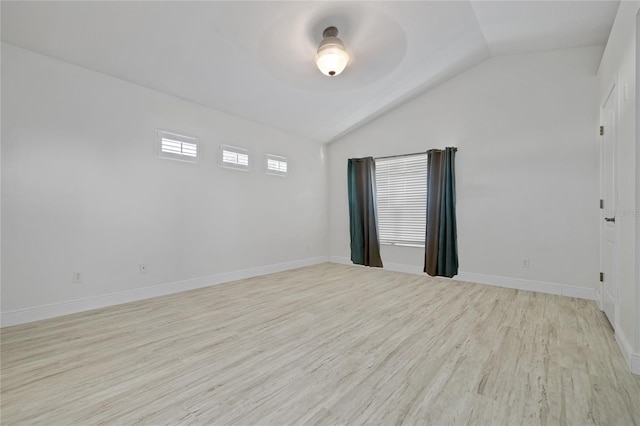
329 47 602 297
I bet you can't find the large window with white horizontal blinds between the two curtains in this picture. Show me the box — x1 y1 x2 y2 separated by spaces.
376 153 427 247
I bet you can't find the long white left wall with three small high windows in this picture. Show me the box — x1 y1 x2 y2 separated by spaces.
2 44 328 325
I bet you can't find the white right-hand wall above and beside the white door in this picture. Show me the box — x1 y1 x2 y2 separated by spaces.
598 1 640 366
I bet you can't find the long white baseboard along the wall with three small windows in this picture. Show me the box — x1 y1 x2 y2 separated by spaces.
0 256 329 327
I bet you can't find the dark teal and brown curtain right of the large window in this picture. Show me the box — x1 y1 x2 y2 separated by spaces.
424 148 458 278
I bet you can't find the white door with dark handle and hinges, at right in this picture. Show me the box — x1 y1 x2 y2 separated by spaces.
601 86 618 329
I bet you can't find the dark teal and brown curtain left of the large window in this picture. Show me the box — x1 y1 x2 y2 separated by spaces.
347 157 382 268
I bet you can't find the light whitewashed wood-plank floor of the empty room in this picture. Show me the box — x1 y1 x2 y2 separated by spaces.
1 264 640 425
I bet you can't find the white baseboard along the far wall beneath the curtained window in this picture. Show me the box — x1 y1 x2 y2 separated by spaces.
329 256 596 300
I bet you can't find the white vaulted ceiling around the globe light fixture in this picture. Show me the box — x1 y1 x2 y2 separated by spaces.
1 1 619 142
